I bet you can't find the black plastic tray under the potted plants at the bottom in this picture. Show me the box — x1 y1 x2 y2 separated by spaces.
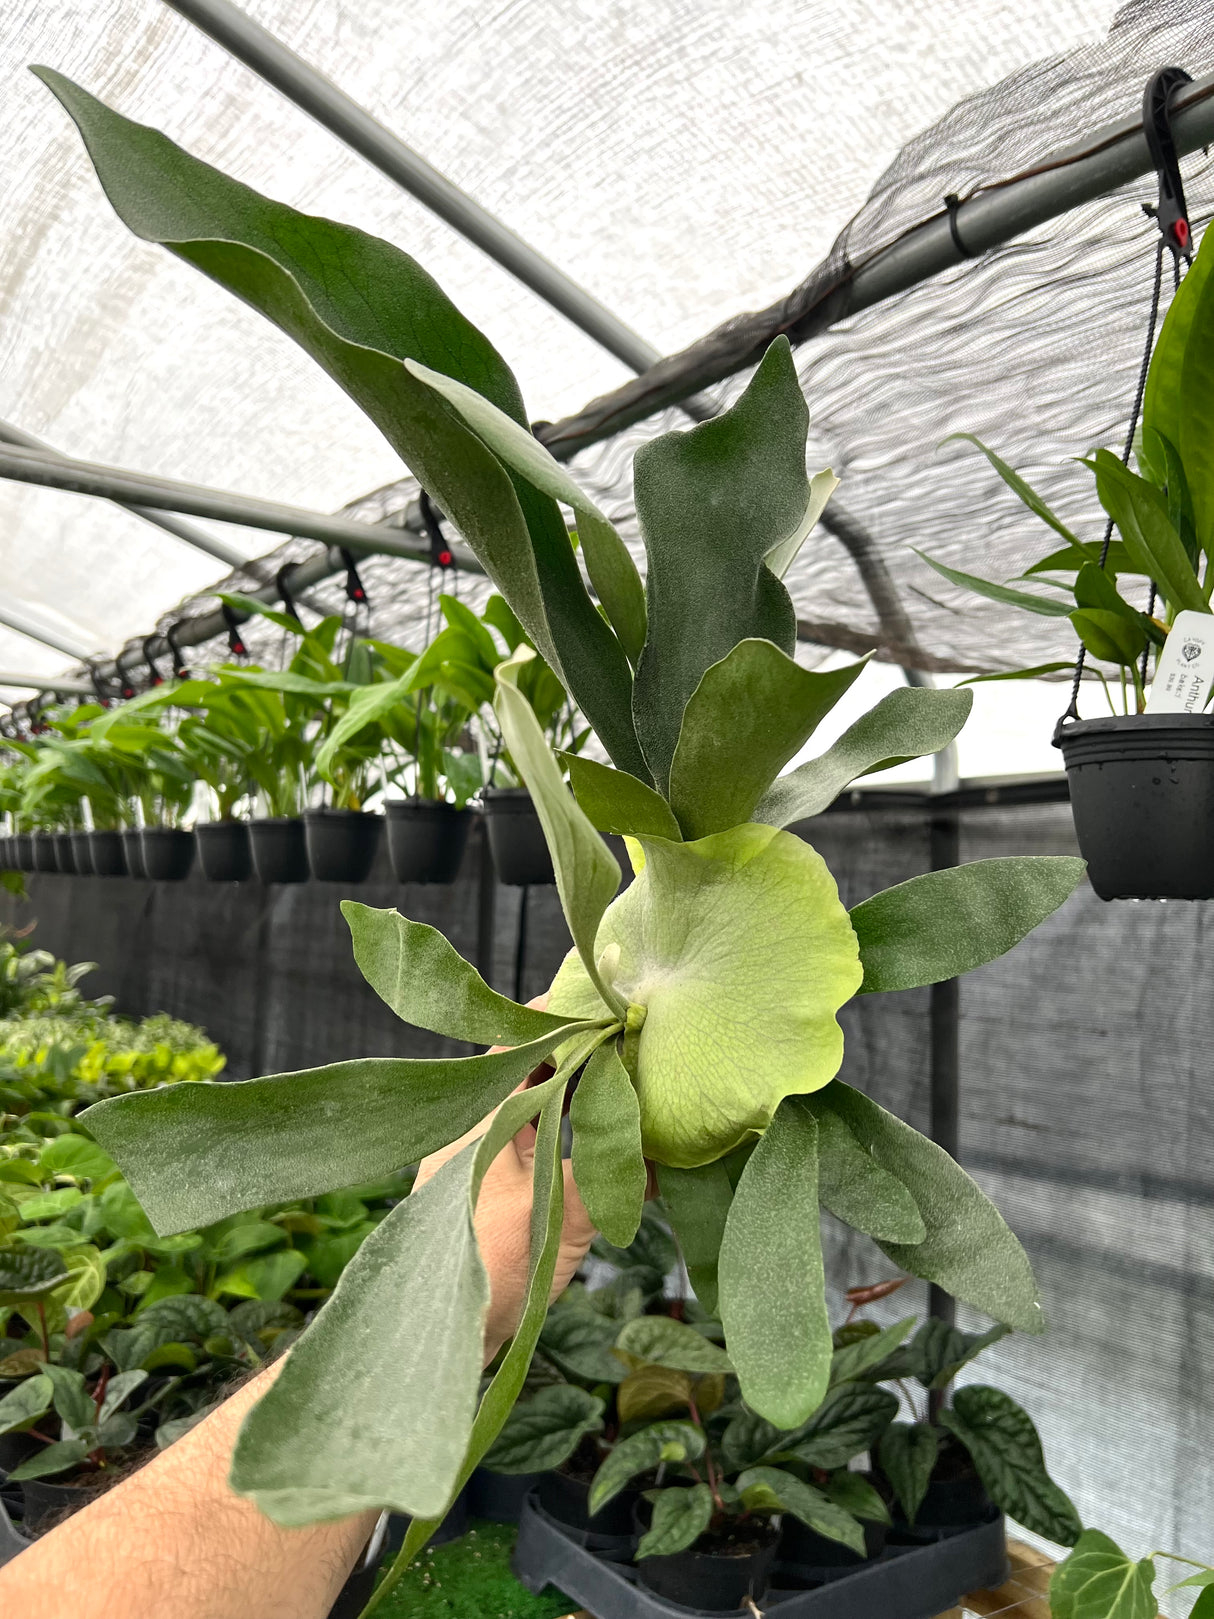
513 1494 1010 1619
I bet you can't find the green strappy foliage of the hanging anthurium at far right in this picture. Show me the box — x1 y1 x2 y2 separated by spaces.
924 220 1214 714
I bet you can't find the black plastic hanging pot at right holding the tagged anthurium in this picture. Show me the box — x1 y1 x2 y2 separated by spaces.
1057 714 1214 900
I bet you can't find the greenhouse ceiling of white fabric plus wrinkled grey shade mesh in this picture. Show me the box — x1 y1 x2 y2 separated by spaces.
0 0 1214 712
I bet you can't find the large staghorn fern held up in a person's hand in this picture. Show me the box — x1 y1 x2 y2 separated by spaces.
37 68 1083 1595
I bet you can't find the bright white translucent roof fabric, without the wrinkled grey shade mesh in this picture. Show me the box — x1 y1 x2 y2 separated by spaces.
0 0 1120 698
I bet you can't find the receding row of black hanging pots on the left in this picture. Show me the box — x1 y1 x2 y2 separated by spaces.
0 788 554 887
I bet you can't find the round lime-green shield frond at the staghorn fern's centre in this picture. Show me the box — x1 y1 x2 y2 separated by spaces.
549 824 861 1169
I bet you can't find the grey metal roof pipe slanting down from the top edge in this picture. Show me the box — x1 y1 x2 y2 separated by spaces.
165 0 660 371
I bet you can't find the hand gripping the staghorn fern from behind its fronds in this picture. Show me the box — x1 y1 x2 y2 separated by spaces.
416 996 596 1363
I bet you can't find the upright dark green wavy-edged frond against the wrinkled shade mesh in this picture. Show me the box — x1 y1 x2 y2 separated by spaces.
628 337 814 788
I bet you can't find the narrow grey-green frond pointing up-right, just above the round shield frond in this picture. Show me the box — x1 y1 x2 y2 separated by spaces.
754 686 974 826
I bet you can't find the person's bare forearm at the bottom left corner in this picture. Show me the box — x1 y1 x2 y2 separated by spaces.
0 1365 376 1619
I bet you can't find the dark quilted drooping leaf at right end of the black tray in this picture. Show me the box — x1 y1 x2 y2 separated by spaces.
940 1383 1083 1546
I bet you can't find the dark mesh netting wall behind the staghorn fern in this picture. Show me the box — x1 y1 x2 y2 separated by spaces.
5 805 1214 1556
